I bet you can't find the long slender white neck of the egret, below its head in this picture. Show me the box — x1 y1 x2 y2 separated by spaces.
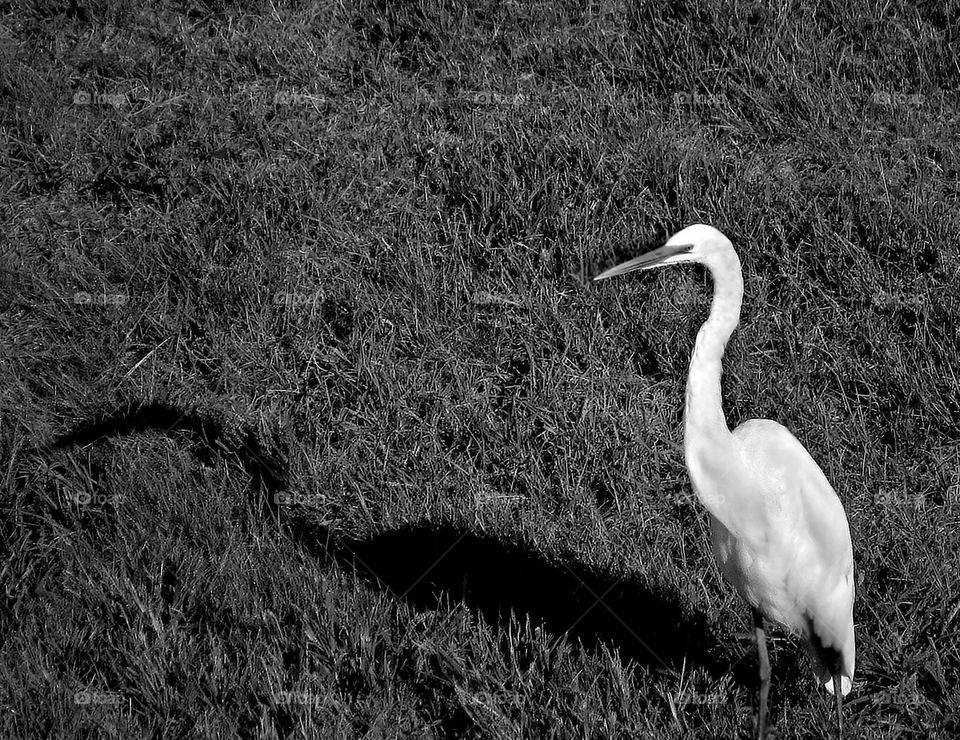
684 250 743 518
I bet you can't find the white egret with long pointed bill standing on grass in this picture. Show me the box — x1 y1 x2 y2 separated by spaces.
594 224 856 738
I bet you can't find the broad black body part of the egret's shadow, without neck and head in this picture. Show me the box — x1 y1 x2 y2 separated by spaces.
288 522 739 676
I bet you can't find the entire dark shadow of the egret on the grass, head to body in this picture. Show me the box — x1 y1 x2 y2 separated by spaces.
18 402 753 683
